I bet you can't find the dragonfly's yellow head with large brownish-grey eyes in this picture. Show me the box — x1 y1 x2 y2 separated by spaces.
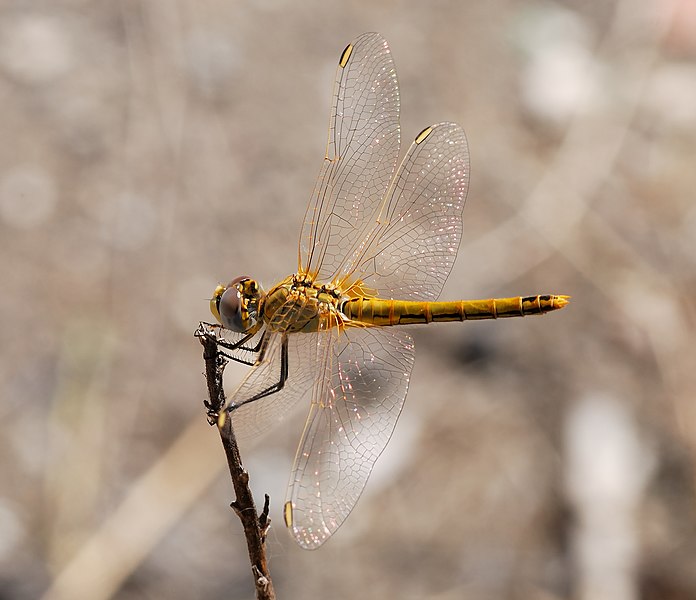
210 276 263 333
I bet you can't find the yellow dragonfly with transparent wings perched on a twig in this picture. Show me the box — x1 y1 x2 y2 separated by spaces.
205 33 569 549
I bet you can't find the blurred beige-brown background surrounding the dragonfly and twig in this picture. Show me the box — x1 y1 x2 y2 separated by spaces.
0 0 696 600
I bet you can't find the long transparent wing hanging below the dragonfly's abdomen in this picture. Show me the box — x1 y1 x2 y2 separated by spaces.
286 327 414 549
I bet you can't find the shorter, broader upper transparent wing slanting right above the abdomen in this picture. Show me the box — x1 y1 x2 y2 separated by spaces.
335 123 469 300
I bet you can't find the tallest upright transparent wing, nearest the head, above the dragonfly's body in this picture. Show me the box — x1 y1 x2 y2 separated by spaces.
299 33 399 281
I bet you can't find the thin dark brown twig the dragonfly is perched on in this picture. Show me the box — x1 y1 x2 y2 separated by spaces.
195 323 276 600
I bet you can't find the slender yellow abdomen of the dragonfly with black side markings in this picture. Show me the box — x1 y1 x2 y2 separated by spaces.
342 294 568 326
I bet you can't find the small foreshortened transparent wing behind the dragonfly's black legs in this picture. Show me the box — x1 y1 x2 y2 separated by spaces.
229 333 319 440
